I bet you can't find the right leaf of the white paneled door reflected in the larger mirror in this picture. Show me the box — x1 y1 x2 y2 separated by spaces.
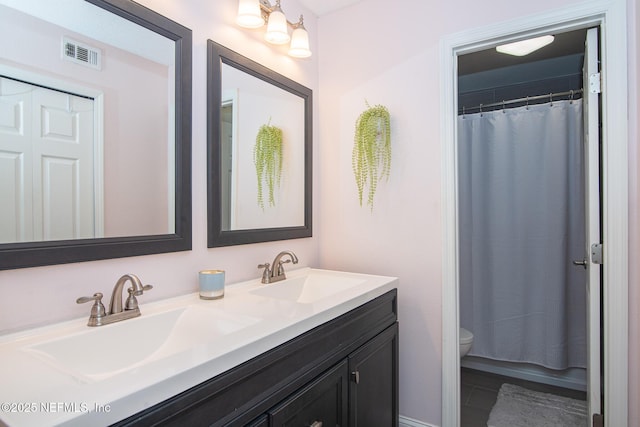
32 88 95 240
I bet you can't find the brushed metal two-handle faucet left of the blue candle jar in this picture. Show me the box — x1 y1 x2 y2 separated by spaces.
76 274 153 326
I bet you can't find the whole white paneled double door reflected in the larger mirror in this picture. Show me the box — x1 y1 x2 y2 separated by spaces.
0 78 95 242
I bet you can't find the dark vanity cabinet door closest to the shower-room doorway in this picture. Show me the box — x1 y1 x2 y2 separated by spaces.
349 323 398 427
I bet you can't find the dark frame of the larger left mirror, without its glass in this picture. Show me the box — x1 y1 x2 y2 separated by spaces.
0 0 192 270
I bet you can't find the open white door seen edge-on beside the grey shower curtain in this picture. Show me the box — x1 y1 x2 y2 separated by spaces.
582 28 601 426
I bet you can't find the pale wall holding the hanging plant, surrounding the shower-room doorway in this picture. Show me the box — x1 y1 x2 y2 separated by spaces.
318 0 640 425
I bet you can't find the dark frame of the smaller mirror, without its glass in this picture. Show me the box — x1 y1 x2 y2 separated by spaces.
207 40 313 248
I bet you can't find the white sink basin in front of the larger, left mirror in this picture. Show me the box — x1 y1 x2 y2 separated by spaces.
25 305 259 382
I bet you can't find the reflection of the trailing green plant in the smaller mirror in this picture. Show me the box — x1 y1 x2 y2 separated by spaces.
253 119 282 210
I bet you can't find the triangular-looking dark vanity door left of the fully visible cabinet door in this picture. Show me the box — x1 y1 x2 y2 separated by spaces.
269 360 349 427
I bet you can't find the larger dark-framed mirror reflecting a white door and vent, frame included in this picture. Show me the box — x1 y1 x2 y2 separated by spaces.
0 0 192 269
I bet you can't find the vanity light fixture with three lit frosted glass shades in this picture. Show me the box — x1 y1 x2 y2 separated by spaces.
236 0 311 58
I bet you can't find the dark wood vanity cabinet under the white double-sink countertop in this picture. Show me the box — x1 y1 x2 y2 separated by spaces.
115 289 398 427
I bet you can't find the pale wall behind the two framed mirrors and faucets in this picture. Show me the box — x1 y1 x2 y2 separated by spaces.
0 0 318 334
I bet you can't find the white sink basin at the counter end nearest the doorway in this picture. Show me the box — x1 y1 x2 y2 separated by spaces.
251 272 366 303
